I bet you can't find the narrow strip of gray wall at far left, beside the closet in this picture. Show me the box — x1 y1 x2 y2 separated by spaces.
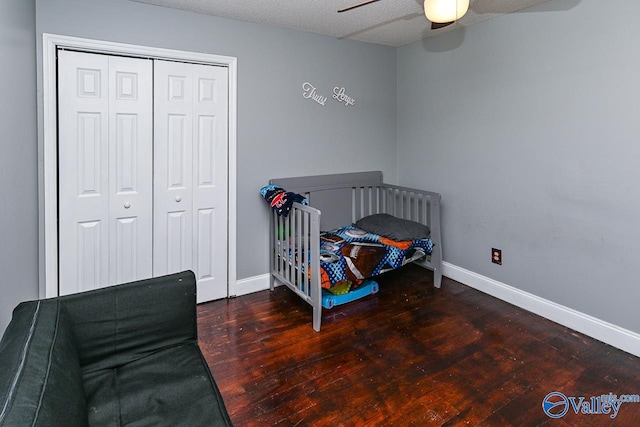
0 0 38 334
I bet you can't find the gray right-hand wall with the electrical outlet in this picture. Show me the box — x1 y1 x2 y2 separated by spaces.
397 0 640 332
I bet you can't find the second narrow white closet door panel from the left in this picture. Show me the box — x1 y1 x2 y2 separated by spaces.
109 57 153 284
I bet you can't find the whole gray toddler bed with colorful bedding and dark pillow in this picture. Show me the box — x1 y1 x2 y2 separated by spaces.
263 171 442 331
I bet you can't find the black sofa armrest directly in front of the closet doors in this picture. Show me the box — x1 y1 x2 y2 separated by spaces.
60 271 198 372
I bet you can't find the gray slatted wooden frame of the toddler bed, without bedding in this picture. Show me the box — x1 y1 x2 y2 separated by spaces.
269 171 442 332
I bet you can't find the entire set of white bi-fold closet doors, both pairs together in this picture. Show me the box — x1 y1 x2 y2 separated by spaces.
58 50 228 302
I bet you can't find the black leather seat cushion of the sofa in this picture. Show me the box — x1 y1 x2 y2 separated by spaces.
84 344 231 426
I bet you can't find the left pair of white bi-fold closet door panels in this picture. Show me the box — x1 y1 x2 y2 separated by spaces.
58 51 153 295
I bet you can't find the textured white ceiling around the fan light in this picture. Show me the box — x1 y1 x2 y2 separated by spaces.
132 0 549 46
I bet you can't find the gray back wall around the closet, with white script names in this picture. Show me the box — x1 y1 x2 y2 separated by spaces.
36 0 396 279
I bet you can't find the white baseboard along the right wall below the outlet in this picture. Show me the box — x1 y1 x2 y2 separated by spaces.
442 262 640 357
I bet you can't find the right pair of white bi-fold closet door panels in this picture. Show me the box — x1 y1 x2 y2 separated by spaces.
153 60 228 302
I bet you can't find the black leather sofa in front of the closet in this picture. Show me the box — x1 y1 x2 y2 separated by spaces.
0 271 231 427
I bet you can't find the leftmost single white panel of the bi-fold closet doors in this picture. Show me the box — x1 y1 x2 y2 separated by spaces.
58 51 109 295
